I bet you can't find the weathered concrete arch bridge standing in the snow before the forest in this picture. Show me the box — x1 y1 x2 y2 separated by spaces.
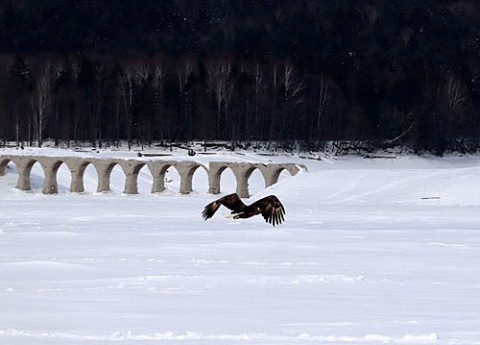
0 155 306 198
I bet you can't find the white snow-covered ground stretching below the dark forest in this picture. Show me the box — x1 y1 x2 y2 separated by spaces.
0 149 480 345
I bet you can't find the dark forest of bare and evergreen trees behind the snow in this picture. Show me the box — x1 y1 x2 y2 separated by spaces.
0 0 480 154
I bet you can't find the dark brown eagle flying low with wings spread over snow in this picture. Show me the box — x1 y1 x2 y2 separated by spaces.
202 193 285 226
